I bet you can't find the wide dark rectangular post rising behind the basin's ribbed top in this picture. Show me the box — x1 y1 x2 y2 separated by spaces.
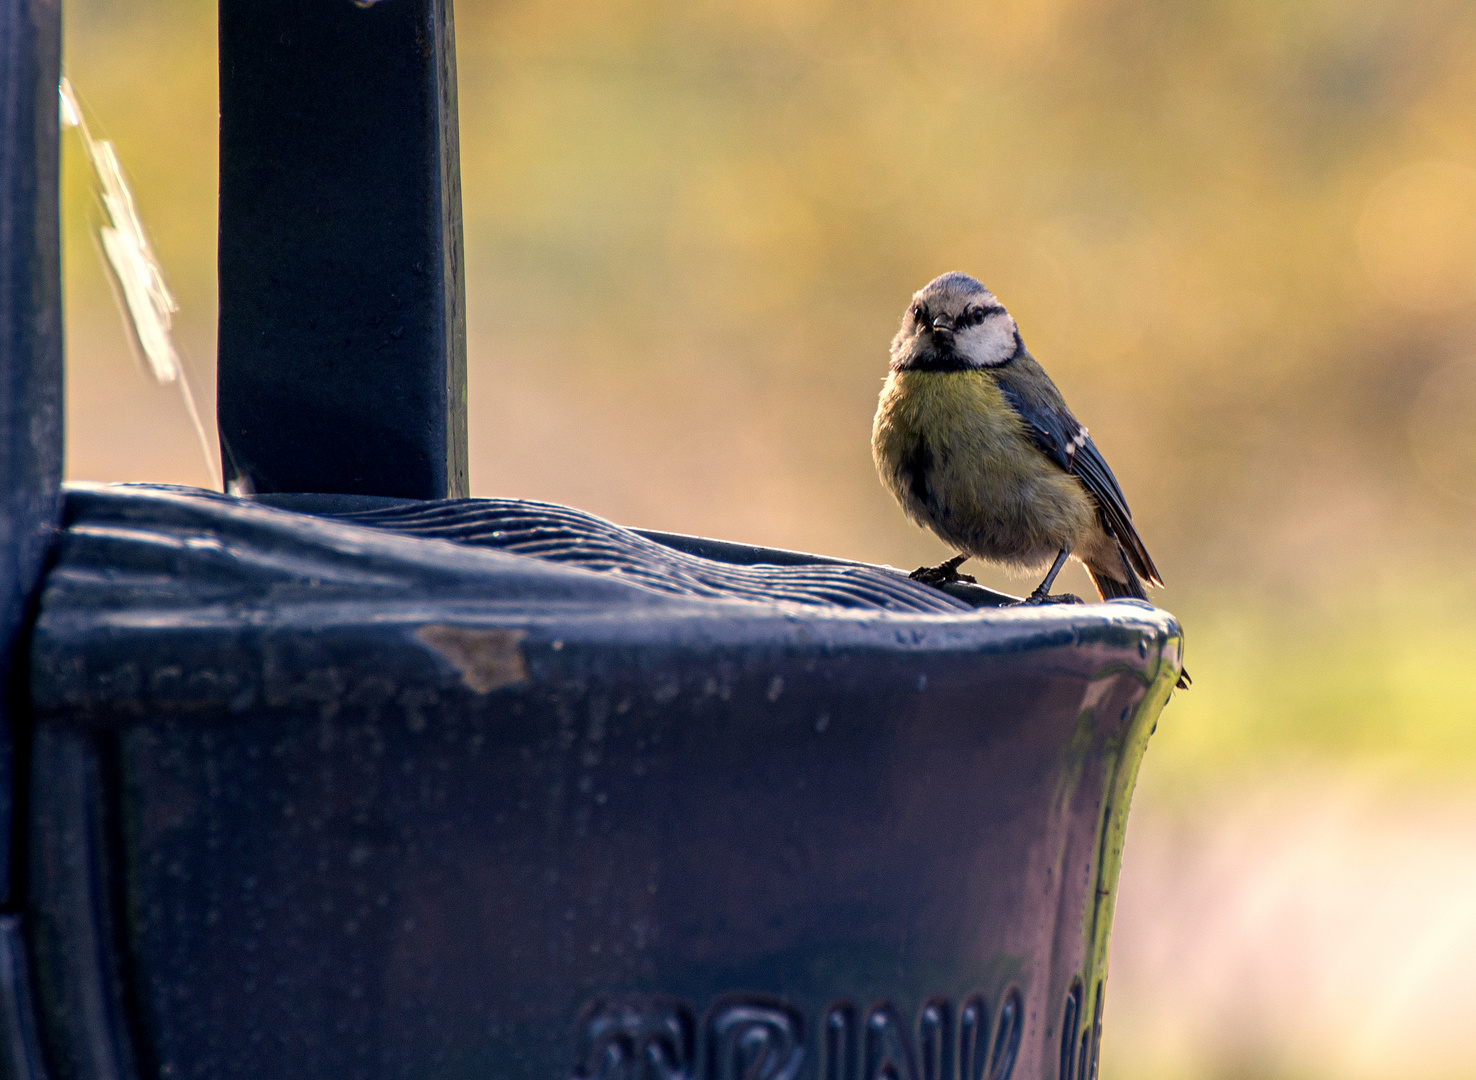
217 0 466 499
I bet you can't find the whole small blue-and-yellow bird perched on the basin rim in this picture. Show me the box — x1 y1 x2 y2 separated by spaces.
871 273 1188 685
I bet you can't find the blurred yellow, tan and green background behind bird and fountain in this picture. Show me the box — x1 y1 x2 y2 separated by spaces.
63 0 1476 1080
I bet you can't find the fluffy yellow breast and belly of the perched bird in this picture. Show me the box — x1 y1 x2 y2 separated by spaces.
871 370 1095 567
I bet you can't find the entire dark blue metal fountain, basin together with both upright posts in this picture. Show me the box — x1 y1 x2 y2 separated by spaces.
0 0 1181 1080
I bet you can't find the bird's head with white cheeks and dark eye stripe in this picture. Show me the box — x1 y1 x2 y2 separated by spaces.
892 271 1024 372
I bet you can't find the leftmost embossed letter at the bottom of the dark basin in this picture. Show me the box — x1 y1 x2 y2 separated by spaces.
573 994 697 1080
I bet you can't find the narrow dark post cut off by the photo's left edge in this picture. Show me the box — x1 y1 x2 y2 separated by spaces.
0 0 62 903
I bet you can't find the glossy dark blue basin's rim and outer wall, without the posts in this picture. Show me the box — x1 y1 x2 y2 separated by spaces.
27 488 1181 1080
